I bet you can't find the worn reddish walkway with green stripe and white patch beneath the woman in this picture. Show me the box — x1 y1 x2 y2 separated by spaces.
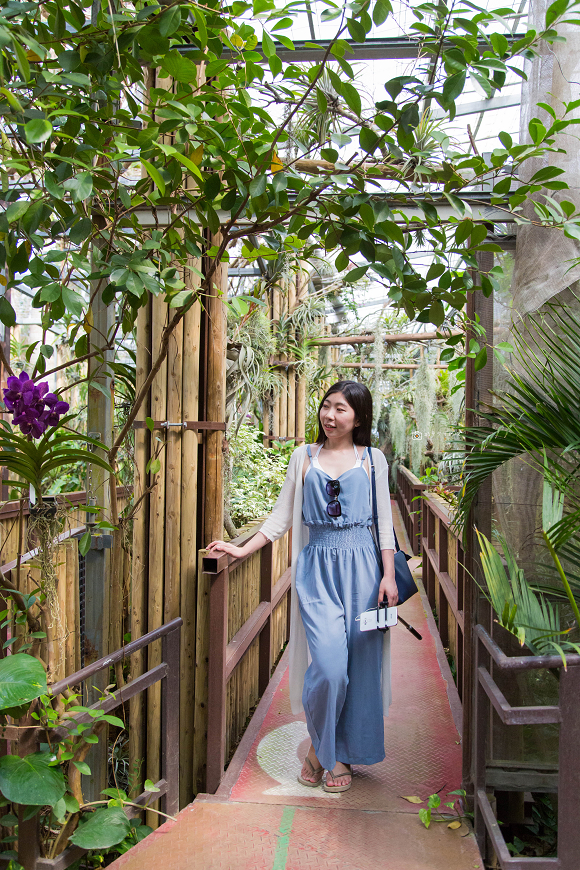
111 508 483 870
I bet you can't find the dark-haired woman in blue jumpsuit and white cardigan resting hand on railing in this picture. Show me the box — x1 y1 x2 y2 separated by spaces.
208 381 398 792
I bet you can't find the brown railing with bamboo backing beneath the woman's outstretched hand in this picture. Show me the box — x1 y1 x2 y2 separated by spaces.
200 524 290 793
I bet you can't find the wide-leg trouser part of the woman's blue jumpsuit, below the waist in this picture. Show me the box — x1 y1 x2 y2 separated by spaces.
296 529 385 770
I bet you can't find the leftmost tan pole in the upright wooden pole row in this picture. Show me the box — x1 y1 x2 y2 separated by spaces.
129 300 151 797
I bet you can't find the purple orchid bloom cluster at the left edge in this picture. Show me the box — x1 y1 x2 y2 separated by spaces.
3 372 70 439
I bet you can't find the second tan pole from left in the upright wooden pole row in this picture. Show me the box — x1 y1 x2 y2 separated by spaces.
146 296 167 828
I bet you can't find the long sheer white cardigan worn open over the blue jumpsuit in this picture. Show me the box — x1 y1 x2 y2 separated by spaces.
260 445 395 716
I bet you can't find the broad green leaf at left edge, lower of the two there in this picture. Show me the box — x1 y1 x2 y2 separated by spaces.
0 752 65 807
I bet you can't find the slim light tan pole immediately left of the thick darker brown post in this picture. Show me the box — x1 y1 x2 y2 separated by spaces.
179 298 201 806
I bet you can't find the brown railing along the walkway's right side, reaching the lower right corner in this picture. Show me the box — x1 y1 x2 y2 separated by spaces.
397 467 580 870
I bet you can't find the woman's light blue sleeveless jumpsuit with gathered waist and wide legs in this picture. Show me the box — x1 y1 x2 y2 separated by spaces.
296 447 385 770
